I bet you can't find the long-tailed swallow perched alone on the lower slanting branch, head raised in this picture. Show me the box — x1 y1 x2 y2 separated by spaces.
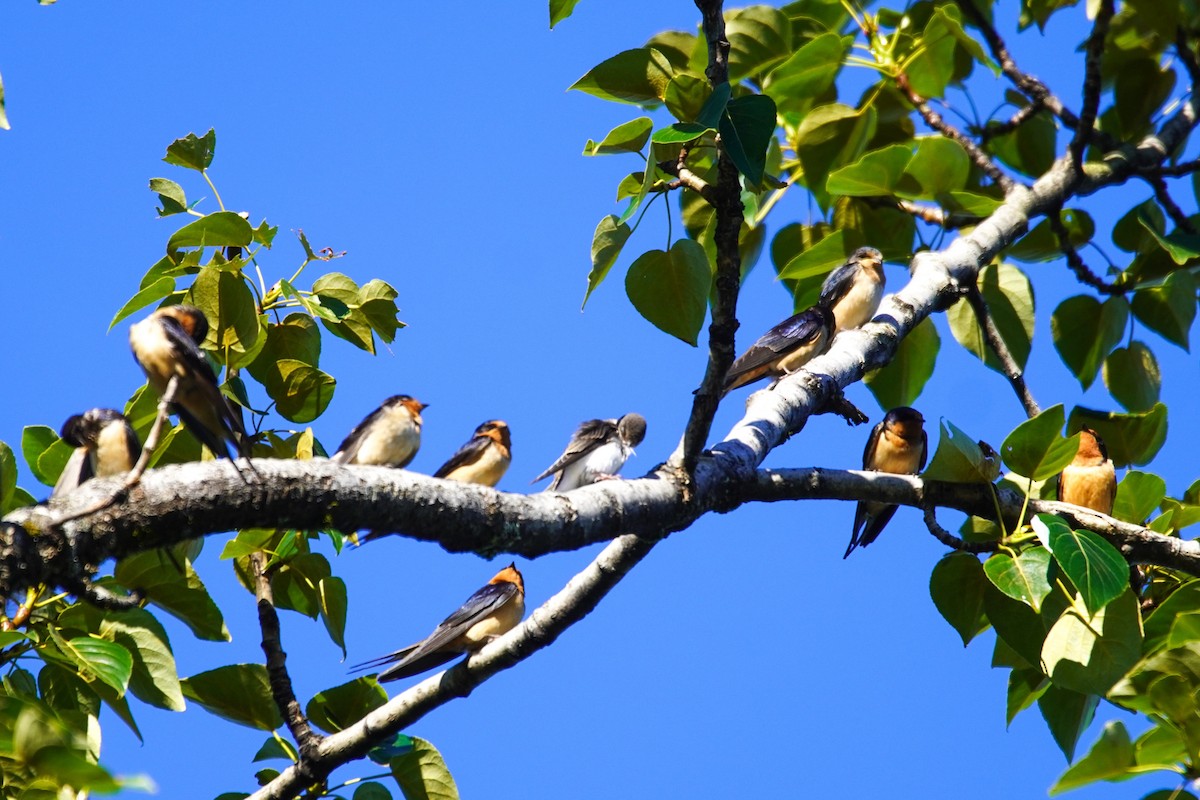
350 563 524 684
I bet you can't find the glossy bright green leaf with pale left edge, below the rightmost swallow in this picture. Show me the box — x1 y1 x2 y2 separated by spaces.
1033 513 1141 618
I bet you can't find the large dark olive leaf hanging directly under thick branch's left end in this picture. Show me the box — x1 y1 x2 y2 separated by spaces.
113 540 229 642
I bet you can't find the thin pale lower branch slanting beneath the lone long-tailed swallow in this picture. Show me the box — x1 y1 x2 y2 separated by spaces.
251 535 659 800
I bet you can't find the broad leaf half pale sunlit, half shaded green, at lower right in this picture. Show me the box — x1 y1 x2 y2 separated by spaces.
1042 585 1141 696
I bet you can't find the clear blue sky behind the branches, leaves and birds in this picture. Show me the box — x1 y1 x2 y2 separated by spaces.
0 0 1200 800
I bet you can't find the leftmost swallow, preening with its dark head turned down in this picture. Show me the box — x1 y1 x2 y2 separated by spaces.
50 408 142 498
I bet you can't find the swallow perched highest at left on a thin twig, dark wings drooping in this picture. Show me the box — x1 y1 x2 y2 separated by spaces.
130 306 250 459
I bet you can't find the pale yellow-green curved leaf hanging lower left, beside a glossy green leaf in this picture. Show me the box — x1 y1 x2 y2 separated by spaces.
100 608 184 711
